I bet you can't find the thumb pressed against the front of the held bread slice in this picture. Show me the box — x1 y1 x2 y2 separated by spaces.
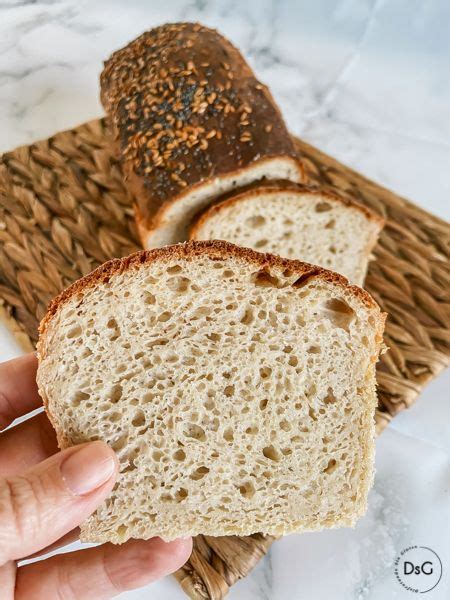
0 442 118 565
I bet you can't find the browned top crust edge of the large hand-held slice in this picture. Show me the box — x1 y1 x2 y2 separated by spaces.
39 240 384 341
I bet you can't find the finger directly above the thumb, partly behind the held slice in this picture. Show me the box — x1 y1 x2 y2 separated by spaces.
0 413 58 477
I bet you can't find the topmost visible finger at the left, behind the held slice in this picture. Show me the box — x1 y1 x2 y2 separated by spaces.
0 353 42 431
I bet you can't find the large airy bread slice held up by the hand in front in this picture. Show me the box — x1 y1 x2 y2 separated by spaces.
38 241 384 543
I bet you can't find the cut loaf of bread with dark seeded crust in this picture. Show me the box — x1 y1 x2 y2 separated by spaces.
101 23 304 248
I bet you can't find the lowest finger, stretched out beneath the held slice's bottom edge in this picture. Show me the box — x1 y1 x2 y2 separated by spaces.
14 538 192 600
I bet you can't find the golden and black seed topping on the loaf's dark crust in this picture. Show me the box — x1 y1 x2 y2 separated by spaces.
102 23 286 197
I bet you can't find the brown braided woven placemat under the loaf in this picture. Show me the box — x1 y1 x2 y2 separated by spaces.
0 120 450 600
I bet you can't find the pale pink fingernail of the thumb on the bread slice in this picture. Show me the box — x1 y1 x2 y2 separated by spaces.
61 443 115 496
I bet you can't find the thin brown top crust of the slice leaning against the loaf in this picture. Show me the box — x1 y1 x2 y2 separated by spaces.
189 180 385 239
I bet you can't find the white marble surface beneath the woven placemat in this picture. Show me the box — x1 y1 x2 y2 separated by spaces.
0 0 450 600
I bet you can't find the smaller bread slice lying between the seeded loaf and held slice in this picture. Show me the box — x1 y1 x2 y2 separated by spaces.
190 183 384 285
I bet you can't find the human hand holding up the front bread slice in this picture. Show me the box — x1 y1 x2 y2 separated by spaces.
0 354 192 600
